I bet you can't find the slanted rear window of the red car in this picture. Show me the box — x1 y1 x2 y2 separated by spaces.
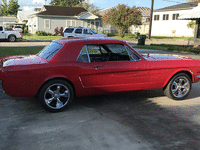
37 42 63 60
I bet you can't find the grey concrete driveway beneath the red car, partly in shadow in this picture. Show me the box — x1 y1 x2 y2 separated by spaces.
0 50 200 150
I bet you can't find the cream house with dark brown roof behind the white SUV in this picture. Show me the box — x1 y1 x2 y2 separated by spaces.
26 5 102 34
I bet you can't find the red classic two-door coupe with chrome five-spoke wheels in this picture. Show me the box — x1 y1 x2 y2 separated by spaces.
0 38 200 112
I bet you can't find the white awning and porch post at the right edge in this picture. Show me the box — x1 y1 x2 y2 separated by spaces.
179 3 200 45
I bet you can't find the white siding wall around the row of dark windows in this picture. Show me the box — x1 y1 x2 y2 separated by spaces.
151 10 194 37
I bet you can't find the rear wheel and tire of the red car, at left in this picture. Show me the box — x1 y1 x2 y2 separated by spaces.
38 79 74 112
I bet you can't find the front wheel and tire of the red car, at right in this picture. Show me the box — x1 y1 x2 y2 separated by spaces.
164 73 192 100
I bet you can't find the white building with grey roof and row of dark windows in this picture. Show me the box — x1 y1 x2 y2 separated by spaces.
151 2 197 37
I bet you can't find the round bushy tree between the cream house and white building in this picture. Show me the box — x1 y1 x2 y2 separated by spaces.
102 4 142 38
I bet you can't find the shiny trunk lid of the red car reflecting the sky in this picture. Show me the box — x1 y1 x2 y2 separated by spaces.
3 55 47 67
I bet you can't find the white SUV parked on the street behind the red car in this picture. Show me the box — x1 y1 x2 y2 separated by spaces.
62 27 107 38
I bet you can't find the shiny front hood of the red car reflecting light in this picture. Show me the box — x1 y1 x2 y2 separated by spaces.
142 54 192 61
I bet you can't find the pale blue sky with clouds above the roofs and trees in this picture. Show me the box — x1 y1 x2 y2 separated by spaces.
18 0 188 10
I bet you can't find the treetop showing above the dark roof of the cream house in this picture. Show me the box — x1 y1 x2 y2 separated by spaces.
50 0 84 7
